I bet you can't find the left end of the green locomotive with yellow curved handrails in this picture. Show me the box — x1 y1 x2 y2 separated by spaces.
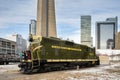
18 35 41 73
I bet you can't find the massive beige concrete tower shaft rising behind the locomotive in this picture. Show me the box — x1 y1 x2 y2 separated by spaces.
36 0 57 37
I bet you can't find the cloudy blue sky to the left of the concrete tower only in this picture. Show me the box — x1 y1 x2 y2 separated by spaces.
0 0 37 39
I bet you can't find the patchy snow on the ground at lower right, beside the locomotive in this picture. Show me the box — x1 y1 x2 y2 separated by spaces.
65 63 120 80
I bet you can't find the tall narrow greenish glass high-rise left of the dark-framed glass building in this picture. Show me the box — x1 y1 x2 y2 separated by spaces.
81 15 92 47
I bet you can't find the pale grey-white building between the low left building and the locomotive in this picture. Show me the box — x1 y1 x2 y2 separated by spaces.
7 34 27 54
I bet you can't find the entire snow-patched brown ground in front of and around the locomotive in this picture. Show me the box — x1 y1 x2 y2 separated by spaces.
0 63 120 80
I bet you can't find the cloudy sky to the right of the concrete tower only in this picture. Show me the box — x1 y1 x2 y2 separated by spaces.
56 0 120 44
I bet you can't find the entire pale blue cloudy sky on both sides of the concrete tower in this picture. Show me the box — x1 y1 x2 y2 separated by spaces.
0 0 120 43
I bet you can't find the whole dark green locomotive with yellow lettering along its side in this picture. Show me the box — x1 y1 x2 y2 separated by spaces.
19 35 99 73
